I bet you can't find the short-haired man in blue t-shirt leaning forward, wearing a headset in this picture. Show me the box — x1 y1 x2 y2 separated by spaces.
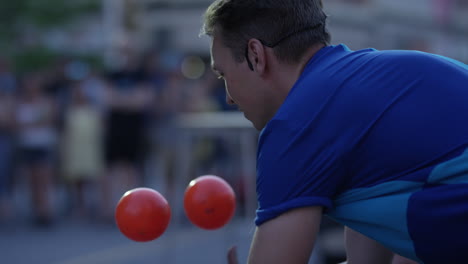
202 0 468 264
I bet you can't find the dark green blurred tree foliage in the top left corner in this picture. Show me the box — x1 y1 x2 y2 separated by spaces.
0 0 101 72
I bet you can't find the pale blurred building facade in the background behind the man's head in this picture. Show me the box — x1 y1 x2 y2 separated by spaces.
23 0 468 71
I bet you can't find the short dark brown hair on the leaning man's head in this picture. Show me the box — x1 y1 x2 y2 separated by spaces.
201 0 330 63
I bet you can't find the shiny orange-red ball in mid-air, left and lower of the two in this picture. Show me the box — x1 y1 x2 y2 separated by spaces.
115 188 171 242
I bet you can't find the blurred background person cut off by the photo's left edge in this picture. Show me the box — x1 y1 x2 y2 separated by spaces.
0 58 16 220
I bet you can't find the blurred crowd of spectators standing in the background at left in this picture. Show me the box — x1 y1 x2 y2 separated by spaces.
0 50 231 227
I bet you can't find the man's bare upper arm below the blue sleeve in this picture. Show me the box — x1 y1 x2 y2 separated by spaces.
248 206 322 264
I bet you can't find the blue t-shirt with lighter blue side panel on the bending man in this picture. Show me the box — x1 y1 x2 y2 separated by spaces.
255 45 468 264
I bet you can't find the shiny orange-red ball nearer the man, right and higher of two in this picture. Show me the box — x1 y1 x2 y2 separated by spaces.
184 175 236 230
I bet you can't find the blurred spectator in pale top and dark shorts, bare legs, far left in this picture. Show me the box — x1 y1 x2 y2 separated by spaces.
16 73 58 226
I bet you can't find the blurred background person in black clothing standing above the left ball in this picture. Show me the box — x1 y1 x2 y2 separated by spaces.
103 50 154 220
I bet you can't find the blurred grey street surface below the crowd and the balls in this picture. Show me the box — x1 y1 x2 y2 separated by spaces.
0 160 254 264
